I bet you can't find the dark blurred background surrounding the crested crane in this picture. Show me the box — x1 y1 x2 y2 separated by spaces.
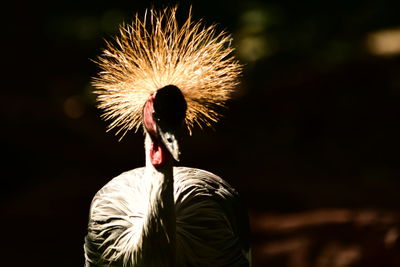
0 0 400 267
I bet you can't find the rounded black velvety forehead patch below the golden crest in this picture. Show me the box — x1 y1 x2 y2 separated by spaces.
154 85 187 125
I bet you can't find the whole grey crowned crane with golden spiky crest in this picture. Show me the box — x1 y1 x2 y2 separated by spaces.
84 7 251 267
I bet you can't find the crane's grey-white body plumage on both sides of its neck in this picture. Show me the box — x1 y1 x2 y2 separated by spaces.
84 167 249 267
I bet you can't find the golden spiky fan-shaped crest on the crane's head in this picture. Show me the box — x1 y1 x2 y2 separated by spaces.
93 7 242 137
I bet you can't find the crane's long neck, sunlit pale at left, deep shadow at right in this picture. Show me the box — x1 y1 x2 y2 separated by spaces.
142 134 176 266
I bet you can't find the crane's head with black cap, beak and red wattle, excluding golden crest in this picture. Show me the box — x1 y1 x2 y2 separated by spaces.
143 85 187 167
